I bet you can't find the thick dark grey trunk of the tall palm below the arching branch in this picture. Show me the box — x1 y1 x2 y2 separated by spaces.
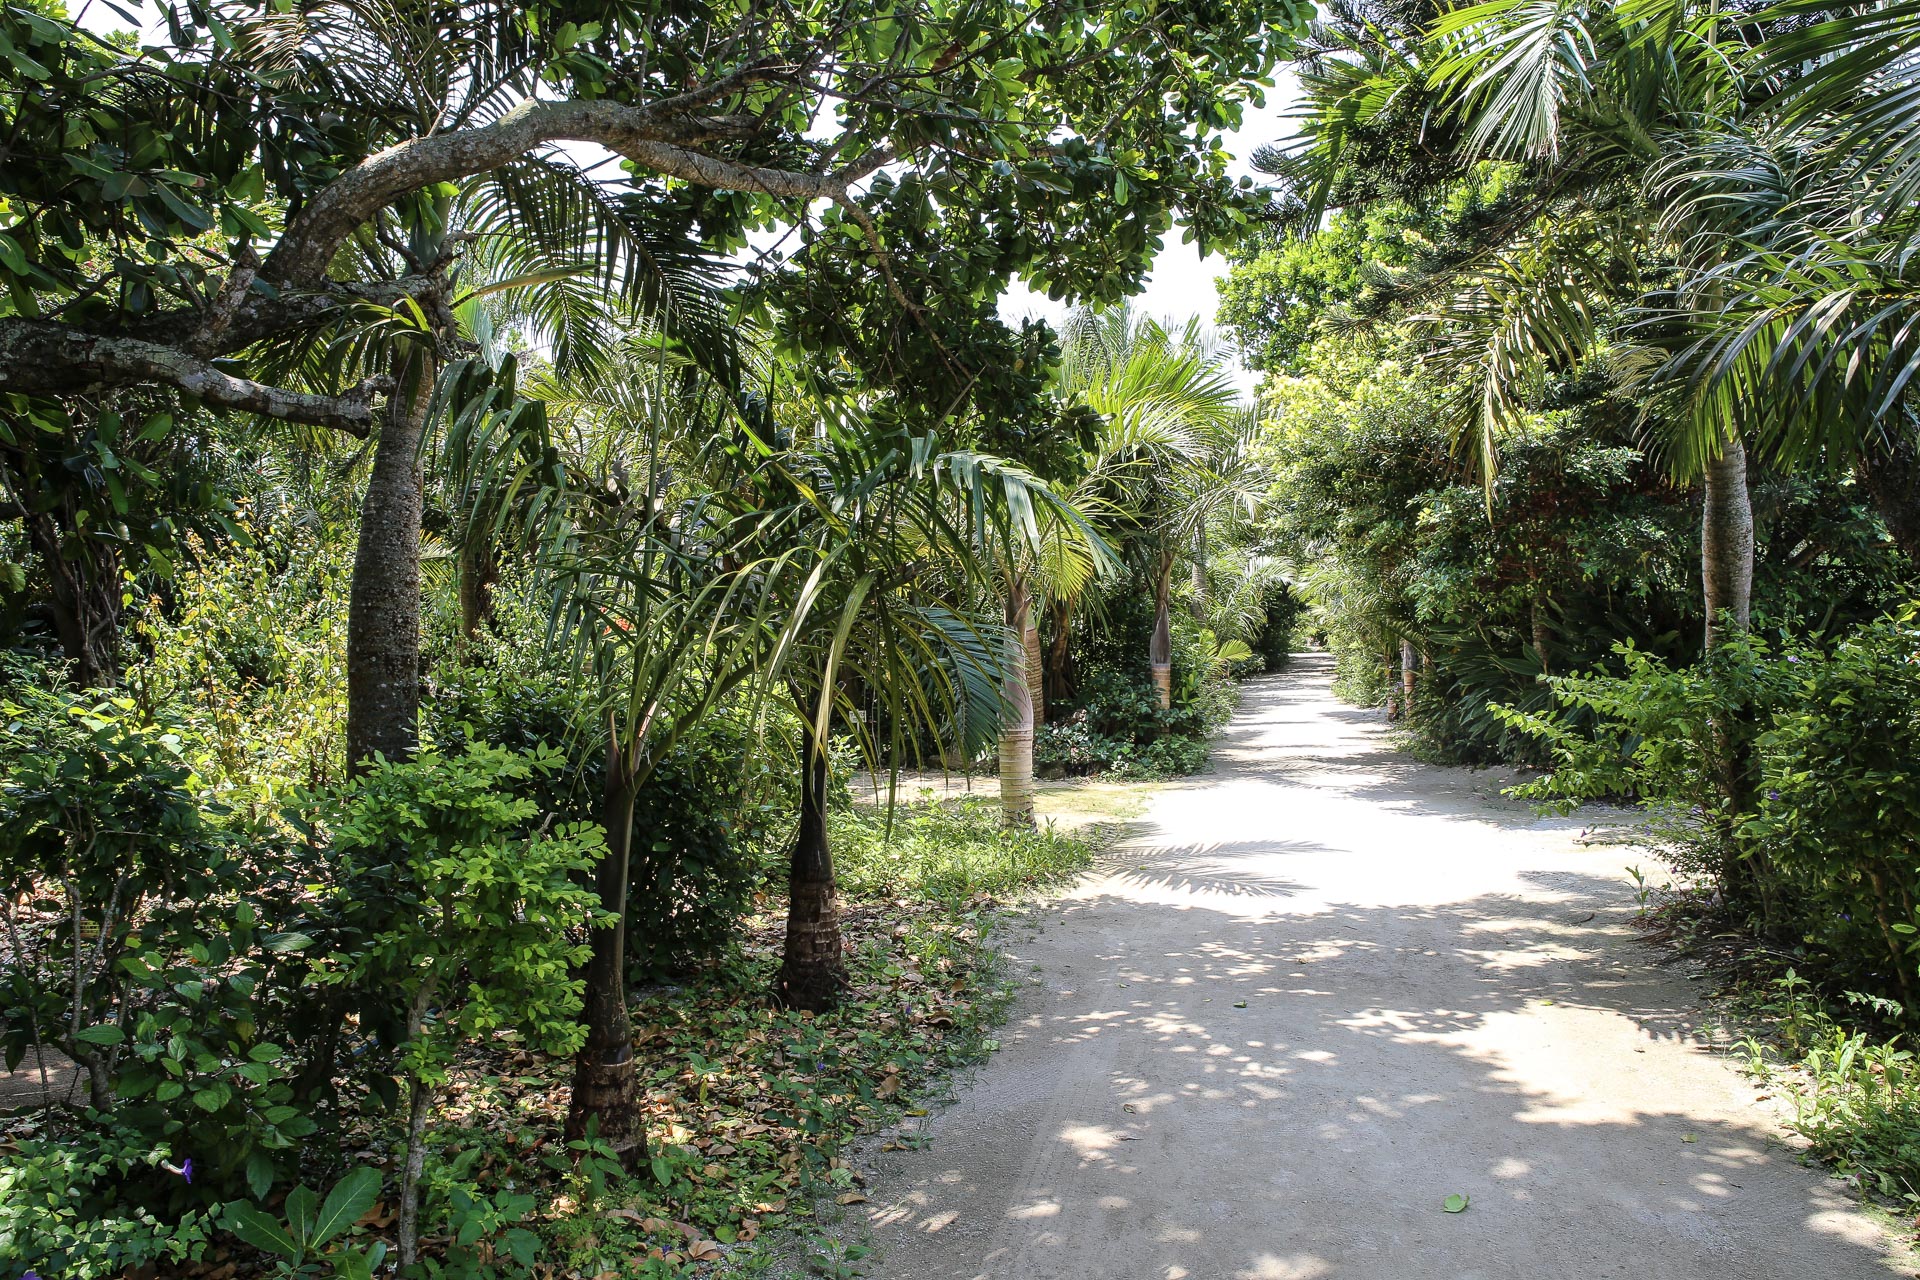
348 345 438 770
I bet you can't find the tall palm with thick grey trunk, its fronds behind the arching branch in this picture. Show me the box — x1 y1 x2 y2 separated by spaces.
222 0 728 768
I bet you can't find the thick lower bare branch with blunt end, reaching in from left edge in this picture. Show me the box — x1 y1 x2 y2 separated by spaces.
0 317 384 436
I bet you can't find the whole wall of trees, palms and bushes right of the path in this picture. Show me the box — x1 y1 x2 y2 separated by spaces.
1221 0 1920 1228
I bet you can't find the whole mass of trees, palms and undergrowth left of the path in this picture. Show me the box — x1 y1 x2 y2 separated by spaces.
0 0 1306 1280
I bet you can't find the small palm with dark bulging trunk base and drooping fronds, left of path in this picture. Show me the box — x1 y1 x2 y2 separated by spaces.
730 415 1077 1011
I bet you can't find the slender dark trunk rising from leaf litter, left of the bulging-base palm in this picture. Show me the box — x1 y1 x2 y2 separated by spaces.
566 735 647 1165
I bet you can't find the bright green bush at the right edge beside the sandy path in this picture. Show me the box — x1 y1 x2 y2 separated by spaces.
1507 620 1920 1019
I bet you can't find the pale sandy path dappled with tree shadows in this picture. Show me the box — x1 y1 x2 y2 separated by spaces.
868 656 1914 1280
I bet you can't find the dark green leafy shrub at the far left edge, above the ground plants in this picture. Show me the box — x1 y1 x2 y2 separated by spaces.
0 685 313 1209
